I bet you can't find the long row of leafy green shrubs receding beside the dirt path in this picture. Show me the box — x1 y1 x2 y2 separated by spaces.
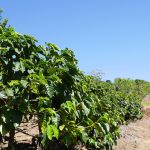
0 18 150 149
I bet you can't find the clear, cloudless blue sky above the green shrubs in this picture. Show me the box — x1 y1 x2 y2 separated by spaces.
0 0 150 81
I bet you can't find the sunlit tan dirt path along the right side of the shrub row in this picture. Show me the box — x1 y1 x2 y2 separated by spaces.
114 96 150 150
